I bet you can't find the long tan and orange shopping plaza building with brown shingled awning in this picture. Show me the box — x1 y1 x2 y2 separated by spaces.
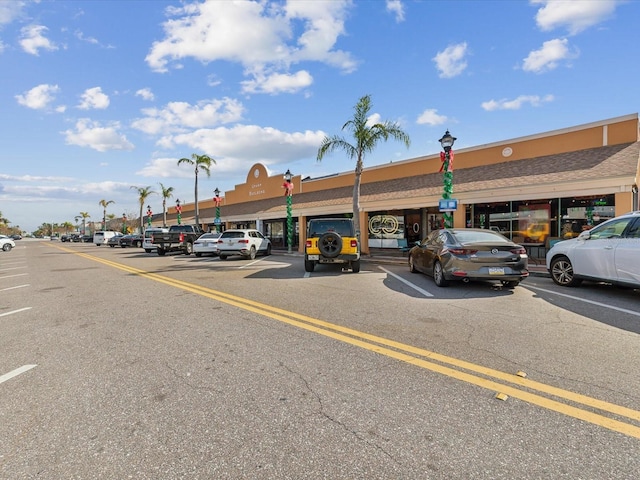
153 113 640 258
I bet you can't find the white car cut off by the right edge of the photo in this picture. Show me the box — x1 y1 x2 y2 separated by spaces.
546 211 640 288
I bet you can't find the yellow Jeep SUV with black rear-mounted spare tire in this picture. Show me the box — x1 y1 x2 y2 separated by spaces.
304 218 360 273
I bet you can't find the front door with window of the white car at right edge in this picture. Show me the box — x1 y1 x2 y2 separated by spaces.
571 217 633 281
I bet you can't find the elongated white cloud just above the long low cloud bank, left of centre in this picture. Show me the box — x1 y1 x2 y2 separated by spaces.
131 98 244 135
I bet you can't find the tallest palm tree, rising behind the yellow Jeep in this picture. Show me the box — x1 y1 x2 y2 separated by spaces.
317 95 411 240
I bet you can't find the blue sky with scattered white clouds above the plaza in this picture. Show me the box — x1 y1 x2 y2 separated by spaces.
0 0 640 231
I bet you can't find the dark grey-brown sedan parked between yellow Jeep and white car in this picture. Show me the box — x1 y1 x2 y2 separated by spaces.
409 228 529 288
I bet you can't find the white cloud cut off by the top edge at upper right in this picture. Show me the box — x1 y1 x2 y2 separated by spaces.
531 0 621 35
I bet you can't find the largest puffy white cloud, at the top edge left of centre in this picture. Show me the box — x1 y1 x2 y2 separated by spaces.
146 0 356 89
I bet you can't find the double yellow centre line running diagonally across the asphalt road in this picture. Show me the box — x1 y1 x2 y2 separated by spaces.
52 247 640 438
